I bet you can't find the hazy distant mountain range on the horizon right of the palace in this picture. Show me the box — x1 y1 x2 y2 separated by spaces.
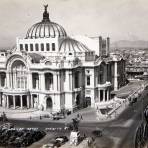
111 40 148 49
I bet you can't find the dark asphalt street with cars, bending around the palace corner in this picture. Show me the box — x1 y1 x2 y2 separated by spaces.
4 87 148 148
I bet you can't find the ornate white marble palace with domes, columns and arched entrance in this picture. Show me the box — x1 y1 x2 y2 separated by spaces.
0 6 125 112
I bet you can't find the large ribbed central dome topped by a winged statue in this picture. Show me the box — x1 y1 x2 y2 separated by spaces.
26 5 67 39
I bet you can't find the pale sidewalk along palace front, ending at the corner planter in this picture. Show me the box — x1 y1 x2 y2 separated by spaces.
0 107 98 123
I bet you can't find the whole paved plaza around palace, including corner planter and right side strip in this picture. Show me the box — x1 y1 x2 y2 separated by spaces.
0 81 146 123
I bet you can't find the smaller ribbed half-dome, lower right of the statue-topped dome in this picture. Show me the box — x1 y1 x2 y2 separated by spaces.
59 37 90 52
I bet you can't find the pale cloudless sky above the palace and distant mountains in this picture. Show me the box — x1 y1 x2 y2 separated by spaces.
0 0 148 48
